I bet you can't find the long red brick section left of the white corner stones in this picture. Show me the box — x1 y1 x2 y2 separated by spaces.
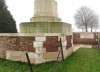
0 36 35 58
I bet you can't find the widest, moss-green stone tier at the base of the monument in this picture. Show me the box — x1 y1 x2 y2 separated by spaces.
20 22 71 34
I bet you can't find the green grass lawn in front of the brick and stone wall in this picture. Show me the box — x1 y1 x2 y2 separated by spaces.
0 48 100 72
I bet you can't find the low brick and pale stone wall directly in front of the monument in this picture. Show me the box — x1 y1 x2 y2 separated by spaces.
0 33 73 63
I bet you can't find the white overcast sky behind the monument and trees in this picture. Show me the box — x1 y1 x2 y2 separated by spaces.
6 0 100 31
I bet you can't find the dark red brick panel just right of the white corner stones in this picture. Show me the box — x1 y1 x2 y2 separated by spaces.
43 36 60 52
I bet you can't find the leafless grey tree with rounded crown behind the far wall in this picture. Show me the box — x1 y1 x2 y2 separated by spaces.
74 6 99 32
